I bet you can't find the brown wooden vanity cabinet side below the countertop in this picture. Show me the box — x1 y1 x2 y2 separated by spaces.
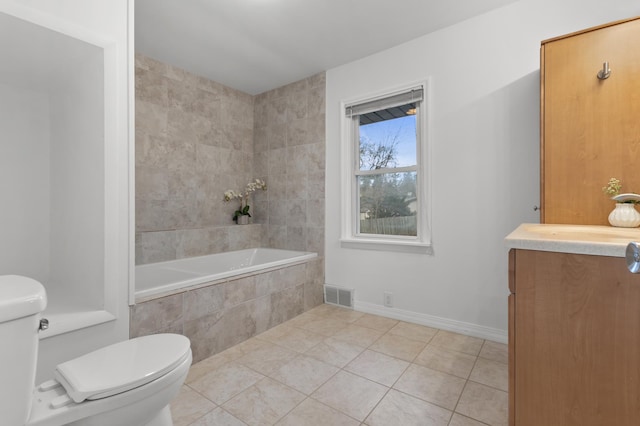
509 249 640 426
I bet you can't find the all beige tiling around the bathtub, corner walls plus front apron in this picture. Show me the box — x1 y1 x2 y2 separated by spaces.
131 54 325 350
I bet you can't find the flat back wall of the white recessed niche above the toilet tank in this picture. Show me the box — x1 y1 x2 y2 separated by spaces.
0 84 49 282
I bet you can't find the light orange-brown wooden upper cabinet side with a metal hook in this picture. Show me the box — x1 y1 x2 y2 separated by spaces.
540 18 640 225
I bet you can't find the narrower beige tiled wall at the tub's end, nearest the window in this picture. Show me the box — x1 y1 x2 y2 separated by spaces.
254 73 325 308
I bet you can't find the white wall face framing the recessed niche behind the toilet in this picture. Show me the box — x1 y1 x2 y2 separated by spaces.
0 0 133 380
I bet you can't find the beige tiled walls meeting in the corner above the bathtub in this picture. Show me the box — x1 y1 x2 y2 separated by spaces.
136 54 325 264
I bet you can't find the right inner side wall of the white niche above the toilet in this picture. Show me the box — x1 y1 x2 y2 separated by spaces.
46 45 105 310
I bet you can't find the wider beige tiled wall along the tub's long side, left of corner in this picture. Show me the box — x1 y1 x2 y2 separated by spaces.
135 54 262 264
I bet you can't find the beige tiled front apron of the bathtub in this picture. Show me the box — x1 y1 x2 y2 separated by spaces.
130 260 321 362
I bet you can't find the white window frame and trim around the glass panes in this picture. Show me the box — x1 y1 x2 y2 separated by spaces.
340 79 433 254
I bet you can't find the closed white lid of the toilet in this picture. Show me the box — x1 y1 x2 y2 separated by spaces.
54 334 190 402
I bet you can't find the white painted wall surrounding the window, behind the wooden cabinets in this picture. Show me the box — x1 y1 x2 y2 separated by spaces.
326 0 640 341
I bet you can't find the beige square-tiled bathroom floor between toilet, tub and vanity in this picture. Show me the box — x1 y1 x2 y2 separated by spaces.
171 305 507 426
